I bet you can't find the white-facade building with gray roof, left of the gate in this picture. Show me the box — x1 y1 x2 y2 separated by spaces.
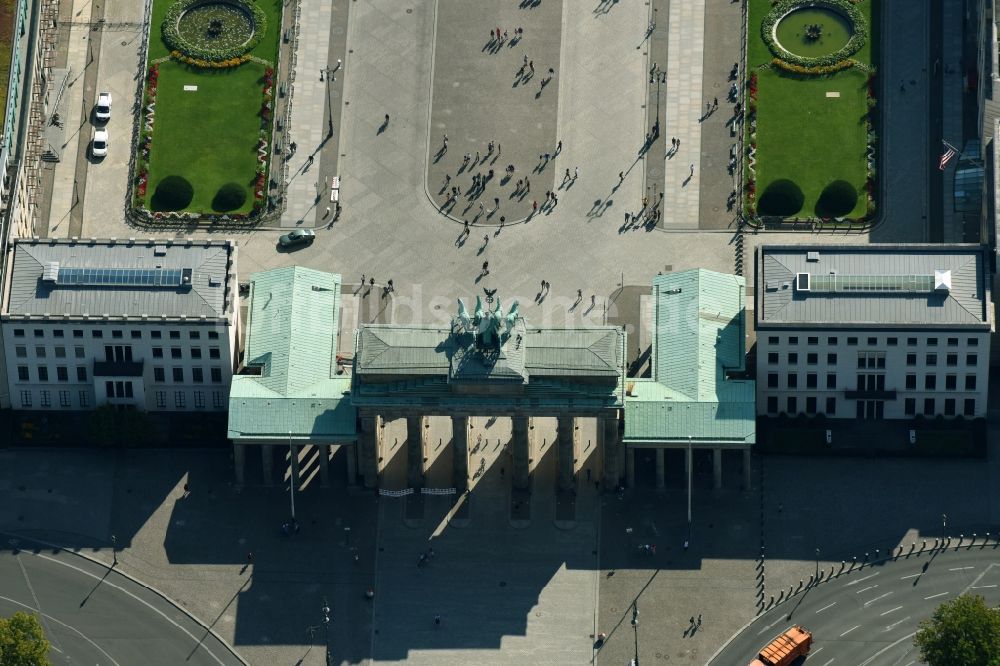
0 239 239 411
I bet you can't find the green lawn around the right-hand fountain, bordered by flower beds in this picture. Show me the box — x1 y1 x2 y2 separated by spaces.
747 0 878 223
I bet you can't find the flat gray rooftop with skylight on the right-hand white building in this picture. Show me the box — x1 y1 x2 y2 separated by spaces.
756 245 991 329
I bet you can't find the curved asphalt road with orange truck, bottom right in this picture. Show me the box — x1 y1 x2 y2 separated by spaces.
709 539 1000 666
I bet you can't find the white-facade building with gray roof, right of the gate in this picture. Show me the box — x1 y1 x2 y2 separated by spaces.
755 245 993 419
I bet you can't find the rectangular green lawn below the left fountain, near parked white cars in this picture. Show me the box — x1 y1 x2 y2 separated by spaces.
146 60 264 213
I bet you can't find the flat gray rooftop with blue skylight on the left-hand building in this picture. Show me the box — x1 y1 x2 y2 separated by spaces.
3 239 236 317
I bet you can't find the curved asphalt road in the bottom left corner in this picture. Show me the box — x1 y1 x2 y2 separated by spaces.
0 537 246 666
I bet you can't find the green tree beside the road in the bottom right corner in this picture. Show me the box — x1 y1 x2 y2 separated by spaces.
914 594 1000 666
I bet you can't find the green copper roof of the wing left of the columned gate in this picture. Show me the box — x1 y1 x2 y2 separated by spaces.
229 266 355 439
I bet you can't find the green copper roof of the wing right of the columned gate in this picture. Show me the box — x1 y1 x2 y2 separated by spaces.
625 269 756 442
